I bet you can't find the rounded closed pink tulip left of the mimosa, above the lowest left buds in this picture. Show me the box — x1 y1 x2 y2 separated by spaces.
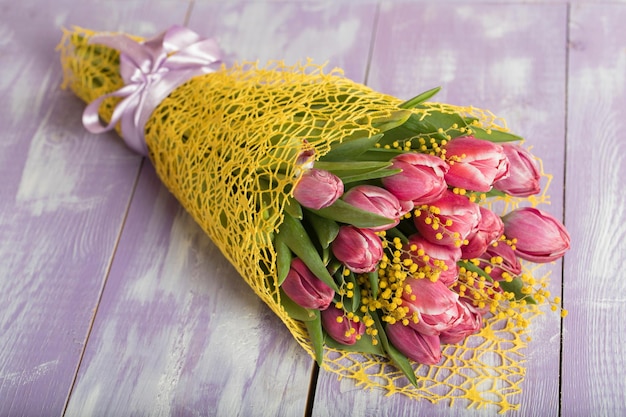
331 226 383 274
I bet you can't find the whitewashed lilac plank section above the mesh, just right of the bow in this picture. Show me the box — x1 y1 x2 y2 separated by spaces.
189 1 377 81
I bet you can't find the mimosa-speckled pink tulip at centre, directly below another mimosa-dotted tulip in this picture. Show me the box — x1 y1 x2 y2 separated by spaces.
408 234 461 287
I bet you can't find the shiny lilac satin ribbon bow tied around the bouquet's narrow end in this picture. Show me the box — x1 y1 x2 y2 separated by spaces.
83 26 221 155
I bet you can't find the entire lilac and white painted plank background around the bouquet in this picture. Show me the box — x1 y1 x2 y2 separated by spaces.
0 0 626 417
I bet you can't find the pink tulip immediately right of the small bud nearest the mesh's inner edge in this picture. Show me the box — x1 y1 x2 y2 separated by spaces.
343 185 406 232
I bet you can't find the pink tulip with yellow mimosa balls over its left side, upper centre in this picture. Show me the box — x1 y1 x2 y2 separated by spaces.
413 191 481 246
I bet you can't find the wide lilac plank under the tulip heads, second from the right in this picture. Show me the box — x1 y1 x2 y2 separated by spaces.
313 3 566 416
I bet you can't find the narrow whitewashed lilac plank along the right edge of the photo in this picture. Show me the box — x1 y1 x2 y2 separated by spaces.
563 4 626 416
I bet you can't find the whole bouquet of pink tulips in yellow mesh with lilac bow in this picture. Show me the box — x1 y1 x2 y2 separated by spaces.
59 26 569 411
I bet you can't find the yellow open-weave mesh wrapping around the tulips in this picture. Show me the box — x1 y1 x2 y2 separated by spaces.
59 28 552 412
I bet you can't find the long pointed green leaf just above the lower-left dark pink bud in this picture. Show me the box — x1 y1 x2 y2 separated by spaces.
279 213 339 292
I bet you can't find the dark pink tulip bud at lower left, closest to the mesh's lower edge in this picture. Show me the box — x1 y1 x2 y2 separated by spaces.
281 258 335 310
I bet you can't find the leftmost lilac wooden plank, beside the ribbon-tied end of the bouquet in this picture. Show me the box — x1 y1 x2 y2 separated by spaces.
0 0 185 415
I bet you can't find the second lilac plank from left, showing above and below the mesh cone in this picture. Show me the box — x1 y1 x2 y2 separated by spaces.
67 2 374 416
